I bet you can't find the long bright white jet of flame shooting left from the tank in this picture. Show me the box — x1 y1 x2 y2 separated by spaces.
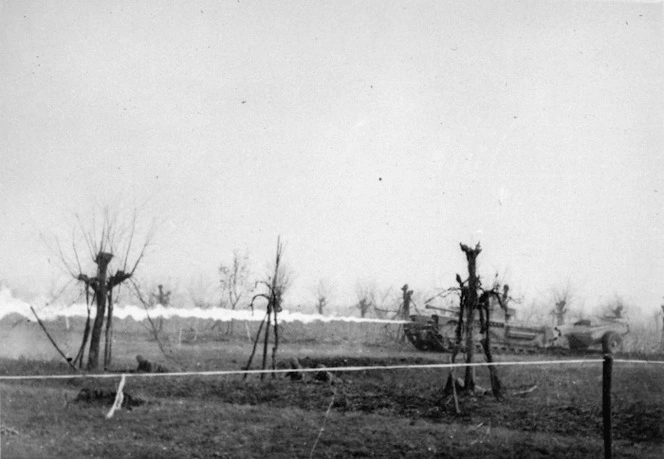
0 288 404 324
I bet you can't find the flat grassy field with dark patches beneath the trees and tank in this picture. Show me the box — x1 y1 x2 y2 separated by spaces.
0 321 664 458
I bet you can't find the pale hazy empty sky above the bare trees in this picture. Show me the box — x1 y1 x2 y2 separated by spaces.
0 0 664 316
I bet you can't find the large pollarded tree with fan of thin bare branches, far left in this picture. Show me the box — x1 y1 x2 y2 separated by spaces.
58 207 154 370
